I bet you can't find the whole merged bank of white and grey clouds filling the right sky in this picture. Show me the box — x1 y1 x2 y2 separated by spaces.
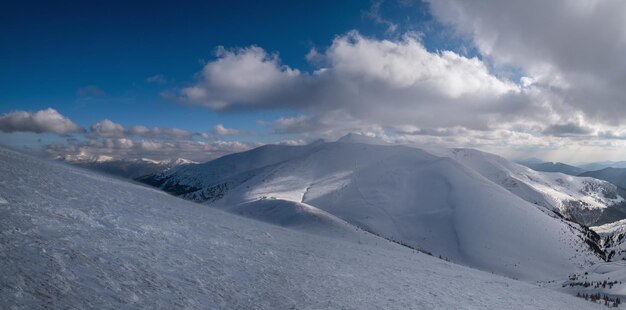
173 20 626 160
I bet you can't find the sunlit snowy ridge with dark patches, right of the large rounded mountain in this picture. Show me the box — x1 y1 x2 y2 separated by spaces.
438 149 626 226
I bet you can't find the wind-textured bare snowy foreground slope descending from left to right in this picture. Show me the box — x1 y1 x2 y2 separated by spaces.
0 148 599 309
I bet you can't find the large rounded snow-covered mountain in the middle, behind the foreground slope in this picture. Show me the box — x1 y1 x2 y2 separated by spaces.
145 142 601 280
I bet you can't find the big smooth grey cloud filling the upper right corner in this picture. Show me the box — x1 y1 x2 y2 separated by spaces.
430 0 626 125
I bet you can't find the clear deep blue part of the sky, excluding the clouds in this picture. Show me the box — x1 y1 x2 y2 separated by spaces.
0 0 451 137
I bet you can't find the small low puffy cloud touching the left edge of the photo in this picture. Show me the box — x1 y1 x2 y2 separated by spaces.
0 108 83 134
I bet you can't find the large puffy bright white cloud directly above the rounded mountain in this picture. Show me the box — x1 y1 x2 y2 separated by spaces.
181 31 541 131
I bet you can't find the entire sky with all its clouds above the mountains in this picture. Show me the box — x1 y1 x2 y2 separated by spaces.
0 0 626 162
